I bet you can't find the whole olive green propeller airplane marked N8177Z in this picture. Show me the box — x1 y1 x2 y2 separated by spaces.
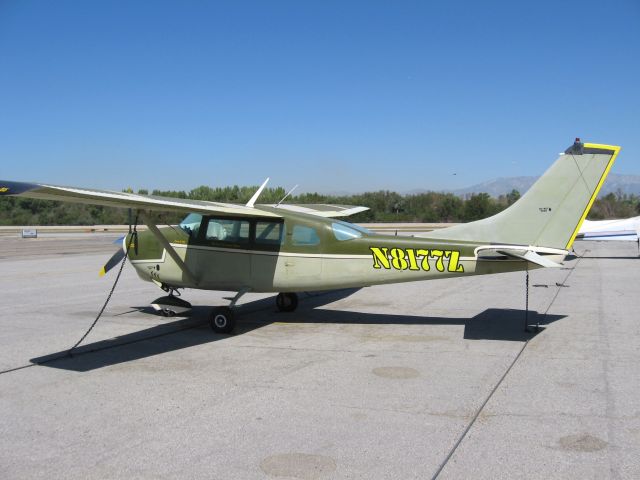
0 139 620 333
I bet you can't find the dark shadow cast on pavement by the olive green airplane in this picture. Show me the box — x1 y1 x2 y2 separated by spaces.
30 289 565 372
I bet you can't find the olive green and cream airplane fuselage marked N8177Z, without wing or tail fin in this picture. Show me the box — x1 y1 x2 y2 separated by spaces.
129 209 561 292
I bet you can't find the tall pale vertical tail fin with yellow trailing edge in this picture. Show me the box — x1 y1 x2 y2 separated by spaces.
425 139 620 250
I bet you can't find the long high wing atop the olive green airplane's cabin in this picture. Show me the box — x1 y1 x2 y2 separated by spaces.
0 180 368 217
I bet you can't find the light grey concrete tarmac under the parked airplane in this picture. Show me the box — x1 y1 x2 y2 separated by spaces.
0 234 640 479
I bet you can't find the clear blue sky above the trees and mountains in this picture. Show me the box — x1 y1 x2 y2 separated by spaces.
0 0 640 192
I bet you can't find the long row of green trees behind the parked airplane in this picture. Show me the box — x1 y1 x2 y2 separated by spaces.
0 185 640 225
